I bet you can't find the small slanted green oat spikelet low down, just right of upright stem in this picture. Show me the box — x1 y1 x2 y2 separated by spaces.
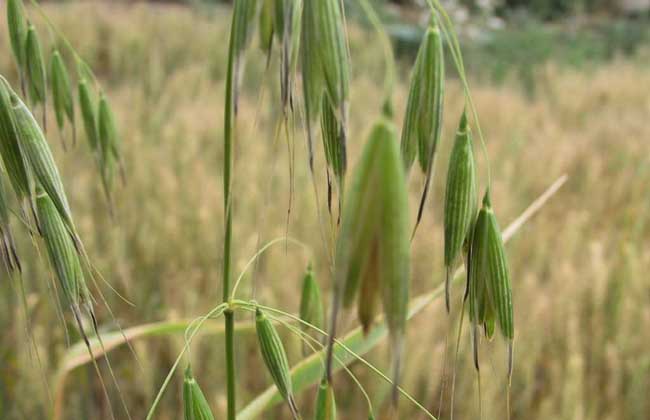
255 308 300 420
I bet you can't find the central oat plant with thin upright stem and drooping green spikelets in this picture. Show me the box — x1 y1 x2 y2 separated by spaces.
142 0 548 420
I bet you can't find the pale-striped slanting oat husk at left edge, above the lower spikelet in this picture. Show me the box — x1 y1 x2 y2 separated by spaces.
12 94 75 234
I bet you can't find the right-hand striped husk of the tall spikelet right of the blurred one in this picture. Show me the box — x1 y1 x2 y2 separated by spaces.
417 22 445 174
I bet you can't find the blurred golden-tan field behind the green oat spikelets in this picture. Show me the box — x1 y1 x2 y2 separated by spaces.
0 3 650 420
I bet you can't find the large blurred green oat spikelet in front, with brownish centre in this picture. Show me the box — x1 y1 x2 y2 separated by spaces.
328 119 410 398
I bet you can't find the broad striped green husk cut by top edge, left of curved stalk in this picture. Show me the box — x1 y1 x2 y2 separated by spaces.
308 0 350 110
